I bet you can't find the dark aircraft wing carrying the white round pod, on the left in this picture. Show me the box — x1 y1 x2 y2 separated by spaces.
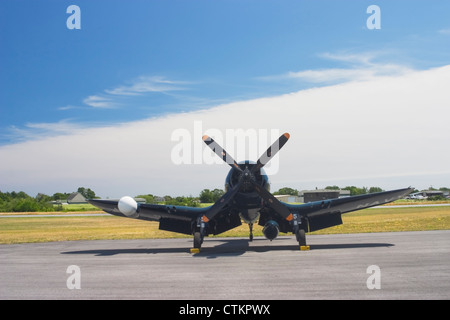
88 199 210 235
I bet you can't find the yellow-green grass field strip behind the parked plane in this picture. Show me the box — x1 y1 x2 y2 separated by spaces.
0 206 450 244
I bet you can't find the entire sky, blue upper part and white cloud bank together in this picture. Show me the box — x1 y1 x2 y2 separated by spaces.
0 0 450 197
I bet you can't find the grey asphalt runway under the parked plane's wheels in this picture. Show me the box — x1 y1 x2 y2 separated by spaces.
0 230 450 300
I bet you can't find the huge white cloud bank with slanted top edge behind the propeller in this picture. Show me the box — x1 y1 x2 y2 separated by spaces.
0 66 450 197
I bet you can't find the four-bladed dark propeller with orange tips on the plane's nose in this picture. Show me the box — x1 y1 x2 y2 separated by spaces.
202 133 293 222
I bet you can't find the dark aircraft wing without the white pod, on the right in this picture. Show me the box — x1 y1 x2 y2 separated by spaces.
283 188 414 232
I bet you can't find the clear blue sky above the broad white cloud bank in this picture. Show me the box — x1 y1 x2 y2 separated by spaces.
0 0 450 145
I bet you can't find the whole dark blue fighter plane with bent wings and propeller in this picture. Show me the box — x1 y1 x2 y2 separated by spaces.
89 133 413 249
